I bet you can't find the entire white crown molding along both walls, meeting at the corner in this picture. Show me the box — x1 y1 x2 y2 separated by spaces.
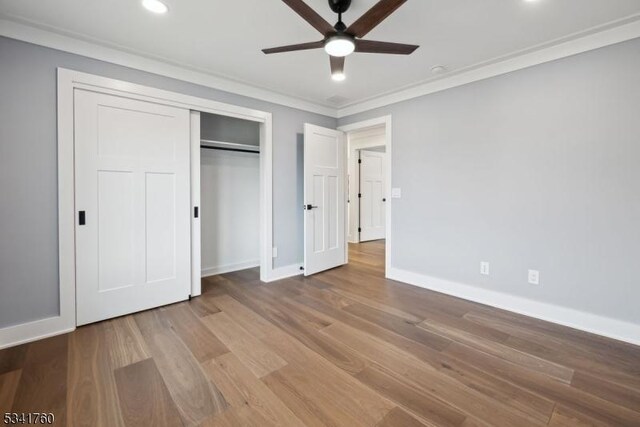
0 14 640 118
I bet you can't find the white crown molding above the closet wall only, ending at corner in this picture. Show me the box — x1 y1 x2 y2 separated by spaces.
0 14 336 118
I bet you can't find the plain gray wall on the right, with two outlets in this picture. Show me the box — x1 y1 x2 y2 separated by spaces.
339 39 640 324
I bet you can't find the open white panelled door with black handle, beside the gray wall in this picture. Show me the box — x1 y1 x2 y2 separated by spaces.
304 124 347 276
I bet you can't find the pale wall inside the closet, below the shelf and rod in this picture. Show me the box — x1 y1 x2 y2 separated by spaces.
200 149 260 276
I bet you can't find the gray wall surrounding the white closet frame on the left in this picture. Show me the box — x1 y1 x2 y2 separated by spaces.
0 37 336 328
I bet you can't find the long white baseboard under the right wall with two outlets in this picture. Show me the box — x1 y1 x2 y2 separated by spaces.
387 267 640 345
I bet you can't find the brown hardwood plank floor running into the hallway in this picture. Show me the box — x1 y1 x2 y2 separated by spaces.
0 242 640 427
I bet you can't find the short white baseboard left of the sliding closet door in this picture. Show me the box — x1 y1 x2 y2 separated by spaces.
0 316 76 350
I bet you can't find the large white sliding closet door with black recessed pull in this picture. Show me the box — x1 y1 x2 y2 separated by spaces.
74 90 191 325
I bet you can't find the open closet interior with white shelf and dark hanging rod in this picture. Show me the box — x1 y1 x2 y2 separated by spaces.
199 113 260 277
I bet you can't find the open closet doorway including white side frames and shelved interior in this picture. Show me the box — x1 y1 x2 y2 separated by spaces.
191 109 275 296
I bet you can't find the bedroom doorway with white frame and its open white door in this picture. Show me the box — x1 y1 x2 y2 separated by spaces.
302 116 391 276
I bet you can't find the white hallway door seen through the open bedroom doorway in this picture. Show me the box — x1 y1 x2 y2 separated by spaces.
360 150 387 242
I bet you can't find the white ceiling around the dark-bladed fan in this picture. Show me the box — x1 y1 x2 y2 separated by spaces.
0 0 640 107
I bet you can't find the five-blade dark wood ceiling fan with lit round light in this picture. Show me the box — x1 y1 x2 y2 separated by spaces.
262 0 420 81
